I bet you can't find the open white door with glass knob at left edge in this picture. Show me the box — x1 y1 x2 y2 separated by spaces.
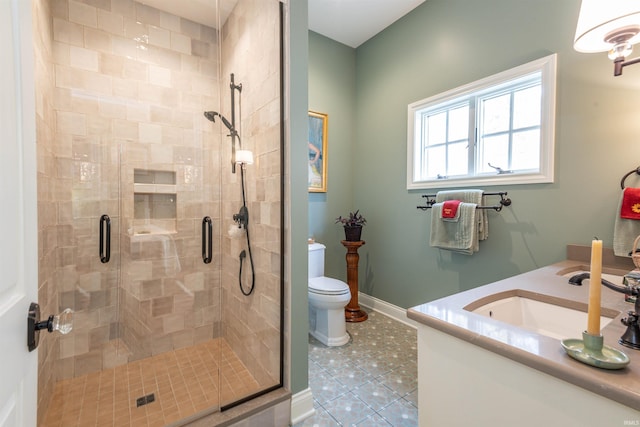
0 0 38 427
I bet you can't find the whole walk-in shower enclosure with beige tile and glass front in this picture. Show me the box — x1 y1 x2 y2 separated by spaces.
32 0 283 426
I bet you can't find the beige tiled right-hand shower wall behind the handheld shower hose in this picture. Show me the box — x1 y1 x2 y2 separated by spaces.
221 0 280 387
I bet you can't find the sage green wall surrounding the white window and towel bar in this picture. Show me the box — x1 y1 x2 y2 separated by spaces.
309 0 640 307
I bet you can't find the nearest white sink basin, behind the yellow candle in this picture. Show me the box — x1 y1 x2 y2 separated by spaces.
465 289 619 339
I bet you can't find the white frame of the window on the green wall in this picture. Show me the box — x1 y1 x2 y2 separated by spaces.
407 54 557 190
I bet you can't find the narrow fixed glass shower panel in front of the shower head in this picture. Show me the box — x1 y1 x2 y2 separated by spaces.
216 0 282 410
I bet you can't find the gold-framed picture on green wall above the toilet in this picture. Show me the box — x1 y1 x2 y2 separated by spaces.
307 111 328 193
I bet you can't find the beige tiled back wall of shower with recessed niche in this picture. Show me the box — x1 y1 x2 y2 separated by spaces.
52 0 220 378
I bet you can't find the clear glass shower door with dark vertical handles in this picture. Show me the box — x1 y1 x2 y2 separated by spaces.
39 0 221 425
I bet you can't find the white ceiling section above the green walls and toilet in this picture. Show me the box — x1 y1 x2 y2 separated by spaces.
309 0 425 48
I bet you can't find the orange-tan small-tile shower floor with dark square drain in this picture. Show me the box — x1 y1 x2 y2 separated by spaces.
39 338 260 427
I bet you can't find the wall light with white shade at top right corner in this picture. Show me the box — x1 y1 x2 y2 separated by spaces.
573 0 640 76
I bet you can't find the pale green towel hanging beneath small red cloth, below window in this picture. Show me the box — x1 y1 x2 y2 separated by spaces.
429 202 479 255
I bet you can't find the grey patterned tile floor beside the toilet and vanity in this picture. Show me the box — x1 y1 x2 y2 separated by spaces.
294 312 418 427
